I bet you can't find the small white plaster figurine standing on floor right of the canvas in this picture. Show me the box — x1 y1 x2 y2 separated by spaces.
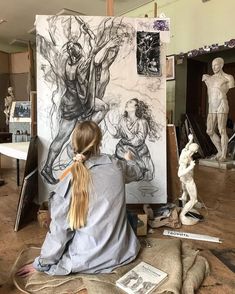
178 134 199 225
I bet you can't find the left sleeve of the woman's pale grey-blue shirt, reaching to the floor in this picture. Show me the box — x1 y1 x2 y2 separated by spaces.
33 177 74 271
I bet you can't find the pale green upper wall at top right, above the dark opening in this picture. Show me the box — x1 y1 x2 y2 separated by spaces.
125 0 235 55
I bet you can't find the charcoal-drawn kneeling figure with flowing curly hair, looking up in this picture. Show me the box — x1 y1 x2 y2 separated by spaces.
105 98 159 181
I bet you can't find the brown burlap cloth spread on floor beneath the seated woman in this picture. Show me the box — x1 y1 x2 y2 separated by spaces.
12 238 209 294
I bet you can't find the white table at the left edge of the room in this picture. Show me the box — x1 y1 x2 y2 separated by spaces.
0 142 29 186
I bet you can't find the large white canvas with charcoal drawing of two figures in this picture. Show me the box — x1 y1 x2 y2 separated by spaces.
36 16 169 203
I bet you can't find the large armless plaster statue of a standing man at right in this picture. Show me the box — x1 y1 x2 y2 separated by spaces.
202 57 235 161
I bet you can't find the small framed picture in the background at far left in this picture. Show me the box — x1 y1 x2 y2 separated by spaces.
10 101 31 122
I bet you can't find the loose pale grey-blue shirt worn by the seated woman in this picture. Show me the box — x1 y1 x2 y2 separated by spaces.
34 154 142 275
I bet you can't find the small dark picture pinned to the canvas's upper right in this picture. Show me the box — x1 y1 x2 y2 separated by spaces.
136 32 160 76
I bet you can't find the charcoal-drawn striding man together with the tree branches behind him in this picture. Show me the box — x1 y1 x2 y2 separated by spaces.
37 16 133 184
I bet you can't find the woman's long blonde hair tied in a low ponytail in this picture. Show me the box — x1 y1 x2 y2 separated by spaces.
68 121 102 230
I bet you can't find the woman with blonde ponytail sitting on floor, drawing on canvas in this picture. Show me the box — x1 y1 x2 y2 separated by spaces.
18 121 142 277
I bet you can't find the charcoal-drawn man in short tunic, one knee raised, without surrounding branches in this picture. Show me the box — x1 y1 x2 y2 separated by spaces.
41 18 123 184
